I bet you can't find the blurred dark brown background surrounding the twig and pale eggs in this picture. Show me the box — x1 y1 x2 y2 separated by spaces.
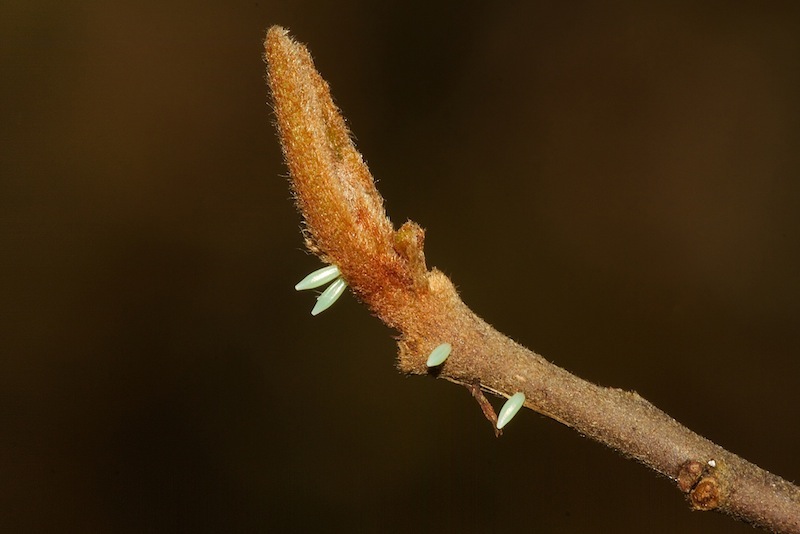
0 0 800 533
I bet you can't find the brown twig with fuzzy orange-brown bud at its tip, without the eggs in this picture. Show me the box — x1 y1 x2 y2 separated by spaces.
265 26 800 533
